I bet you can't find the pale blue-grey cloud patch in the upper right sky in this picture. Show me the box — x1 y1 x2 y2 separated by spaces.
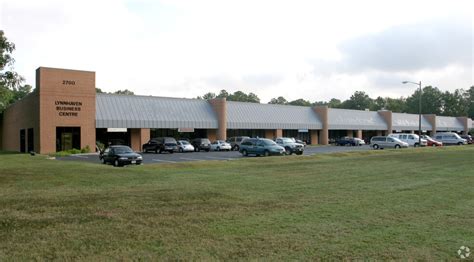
340 19 473 72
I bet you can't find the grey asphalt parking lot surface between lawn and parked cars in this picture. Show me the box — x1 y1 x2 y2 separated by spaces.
58 145 371 164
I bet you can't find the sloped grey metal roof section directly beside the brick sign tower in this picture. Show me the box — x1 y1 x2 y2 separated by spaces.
96 94 217 128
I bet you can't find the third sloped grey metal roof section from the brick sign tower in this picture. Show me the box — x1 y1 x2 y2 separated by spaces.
328 108 388 130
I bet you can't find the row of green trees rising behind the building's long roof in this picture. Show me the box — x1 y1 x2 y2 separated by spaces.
197 86 474 118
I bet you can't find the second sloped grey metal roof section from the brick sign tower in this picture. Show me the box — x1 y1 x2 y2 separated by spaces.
227 101 323 129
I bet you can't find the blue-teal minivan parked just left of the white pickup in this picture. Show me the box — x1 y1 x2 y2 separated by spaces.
239 138 285 156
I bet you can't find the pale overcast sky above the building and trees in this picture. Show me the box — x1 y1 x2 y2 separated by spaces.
0 0 474 103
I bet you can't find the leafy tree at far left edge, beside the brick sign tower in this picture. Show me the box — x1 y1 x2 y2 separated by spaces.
0 30 32 112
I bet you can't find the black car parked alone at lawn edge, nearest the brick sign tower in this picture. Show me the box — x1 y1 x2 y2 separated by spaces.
99 146 143 166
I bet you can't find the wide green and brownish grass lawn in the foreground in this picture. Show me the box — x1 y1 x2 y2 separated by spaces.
0 146 474 261
